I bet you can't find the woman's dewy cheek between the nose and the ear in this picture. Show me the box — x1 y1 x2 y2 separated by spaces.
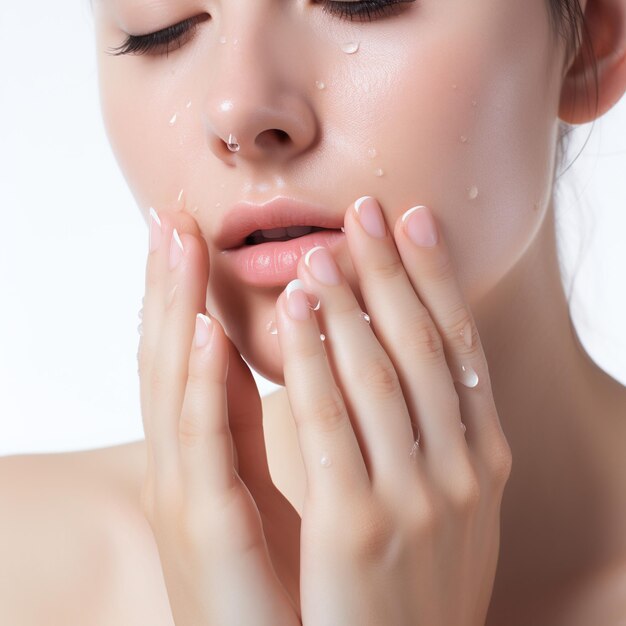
352 2 559 302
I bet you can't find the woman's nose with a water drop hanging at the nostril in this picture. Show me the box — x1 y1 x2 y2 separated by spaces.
204 10 318 165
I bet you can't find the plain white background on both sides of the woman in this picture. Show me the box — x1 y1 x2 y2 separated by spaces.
0 0 626 455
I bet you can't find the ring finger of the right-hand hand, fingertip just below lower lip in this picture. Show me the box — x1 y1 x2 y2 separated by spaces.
298 246 420 492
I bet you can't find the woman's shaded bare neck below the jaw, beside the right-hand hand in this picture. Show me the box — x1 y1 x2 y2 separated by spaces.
472 208 626 594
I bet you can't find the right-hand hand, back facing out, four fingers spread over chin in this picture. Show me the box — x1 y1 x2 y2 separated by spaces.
276 200 511 626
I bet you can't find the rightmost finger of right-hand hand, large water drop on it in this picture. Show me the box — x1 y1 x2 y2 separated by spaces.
394 202 506 470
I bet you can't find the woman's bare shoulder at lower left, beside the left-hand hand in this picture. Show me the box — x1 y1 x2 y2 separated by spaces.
0 441 173 626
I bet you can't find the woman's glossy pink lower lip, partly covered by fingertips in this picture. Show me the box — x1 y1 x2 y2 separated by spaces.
221 230 346 287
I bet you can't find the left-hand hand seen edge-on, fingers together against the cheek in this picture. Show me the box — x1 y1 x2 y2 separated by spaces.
138 212 300 626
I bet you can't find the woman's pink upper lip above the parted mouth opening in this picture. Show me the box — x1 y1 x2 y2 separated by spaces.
215 196 343 250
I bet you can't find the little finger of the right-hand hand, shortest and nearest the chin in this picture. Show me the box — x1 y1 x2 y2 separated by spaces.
276 280 370 501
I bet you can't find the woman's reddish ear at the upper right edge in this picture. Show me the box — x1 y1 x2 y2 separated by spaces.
559 0 626 124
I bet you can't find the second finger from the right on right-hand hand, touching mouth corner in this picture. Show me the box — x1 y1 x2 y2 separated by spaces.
345 197 469 466
